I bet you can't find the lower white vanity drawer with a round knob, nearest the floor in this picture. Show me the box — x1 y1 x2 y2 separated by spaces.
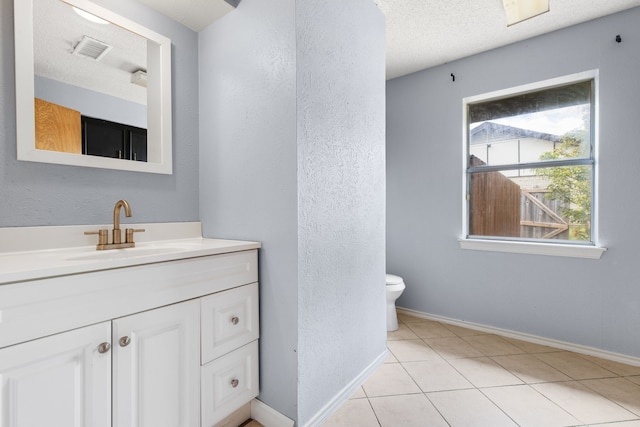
200 340 259 427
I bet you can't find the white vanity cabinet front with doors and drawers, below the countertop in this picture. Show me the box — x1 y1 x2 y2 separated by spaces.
0 249 258 427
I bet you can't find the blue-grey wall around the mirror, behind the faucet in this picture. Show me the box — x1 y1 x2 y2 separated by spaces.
0 0 199 227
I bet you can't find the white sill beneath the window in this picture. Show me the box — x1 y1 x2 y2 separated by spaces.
458 239 607 259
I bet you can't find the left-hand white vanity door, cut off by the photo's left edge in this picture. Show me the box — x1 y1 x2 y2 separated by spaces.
0 322 111 427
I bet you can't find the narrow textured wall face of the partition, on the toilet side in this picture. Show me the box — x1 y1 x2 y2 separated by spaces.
296 0 386 426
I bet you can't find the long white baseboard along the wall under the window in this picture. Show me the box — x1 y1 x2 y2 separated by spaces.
397 307 640 366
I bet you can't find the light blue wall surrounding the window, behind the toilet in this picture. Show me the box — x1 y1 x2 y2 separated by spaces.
387 9 640 357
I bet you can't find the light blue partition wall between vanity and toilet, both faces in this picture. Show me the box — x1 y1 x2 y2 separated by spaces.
199 0 386 426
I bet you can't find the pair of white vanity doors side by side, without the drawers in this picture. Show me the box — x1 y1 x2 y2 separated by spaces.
0 300 200 427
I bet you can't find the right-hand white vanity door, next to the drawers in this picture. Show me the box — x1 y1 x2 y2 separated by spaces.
112 300 200 427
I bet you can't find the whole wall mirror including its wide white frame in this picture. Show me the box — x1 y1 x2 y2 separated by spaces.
14 0 172 174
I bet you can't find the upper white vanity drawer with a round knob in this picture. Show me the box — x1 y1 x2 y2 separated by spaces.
201 283 259 365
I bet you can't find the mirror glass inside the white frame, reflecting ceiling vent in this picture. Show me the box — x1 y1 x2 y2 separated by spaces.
33 0 147 161
